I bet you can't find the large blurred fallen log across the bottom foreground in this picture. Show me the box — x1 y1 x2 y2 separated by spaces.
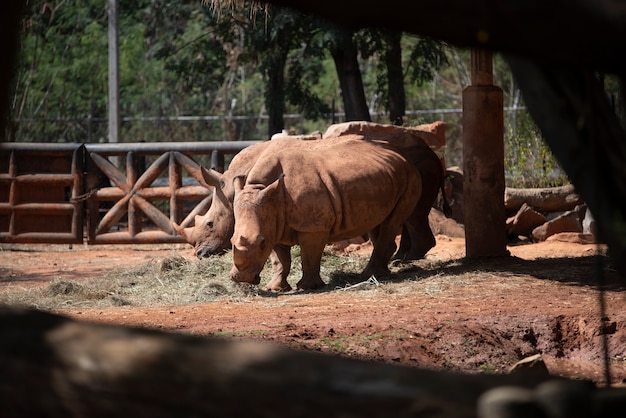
0 308 545 418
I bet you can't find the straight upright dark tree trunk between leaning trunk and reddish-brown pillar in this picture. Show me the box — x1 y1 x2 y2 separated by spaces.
383 32 406 125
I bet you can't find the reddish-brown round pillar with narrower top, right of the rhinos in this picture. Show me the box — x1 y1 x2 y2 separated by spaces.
463 50 508 258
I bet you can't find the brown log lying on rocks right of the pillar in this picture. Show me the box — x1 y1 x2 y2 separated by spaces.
504 184 583 212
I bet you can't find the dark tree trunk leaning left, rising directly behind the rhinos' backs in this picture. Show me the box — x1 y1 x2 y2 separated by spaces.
330 30 371 122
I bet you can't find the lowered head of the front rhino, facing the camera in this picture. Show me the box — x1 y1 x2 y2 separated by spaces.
230 176 282 284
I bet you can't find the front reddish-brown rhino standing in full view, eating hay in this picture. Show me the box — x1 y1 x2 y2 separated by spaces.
230 136 422 290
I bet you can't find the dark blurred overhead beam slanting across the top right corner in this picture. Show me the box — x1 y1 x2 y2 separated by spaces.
270 0 626 74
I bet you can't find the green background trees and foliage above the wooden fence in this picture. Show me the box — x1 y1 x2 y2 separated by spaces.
6 0 576 186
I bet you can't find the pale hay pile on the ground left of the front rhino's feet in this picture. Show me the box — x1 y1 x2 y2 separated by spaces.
0 251 258 310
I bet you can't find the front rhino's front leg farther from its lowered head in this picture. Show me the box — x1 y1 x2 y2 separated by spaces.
296 232 328 290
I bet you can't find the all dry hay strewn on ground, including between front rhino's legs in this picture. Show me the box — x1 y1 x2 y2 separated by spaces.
0 247 454 310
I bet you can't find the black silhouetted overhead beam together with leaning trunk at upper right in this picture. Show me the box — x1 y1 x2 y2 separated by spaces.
271 0 626 276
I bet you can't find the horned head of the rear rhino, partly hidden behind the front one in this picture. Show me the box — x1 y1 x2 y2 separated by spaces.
176 167 235 258
